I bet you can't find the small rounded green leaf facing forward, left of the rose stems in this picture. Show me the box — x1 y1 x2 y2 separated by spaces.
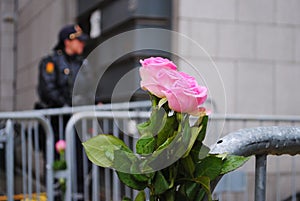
136 136 156 154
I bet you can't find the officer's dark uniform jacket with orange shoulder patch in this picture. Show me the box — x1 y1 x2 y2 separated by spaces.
38 50 83 108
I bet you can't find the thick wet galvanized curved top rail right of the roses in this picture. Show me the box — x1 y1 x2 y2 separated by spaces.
211 126 300 156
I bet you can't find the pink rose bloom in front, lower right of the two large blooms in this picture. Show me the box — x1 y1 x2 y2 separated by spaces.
164 77 207 115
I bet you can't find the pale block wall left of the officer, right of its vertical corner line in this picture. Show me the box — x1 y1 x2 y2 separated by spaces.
15 0 76 110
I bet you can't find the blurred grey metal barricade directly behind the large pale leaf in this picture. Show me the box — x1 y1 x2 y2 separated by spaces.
66 111 149 201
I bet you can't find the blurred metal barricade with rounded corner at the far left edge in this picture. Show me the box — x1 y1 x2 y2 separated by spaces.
0 112 54 201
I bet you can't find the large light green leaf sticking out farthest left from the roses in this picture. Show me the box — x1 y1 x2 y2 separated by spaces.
82 134 132 167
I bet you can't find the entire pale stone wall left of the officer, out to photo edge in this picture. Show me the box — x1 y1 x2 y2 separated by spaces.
0 0 76 111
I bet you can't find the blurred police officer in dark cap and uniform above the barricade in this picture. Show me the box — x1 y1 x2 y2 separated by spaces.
36 25 88 108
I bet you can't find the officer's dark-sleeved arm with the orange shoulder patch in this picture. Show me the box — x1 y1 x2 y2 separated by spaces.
38 58 65 107
